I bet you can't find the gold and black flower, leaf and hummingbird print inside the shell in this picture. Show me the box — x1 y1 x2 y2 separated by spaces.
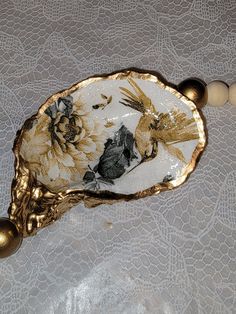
20 78 199 191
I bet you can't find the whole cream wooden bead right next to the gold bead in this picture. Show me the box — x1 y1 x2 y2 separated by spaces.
207 81 229 107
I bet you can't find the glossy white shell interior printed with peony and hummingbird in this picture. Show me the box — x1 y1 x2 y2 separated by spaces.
19 71 205 195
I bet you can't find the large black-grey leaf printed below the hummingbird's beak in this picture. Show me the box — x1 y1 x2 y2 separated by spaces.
97 125 137 180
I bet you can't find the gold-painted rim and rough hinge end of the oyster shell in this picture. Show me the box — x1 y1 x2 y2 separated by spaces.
8 70 206 237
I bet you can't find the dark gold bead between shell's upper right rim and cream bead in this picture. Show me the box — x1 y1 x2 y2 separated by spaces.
178 78 207 108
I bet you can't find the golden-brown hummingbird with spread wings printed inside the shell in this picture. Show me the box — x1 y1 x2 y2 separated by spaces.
120 78 199 163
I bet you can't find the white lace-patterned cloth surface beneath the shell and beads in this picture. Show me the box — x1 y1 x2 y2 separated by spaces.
0 0 236 314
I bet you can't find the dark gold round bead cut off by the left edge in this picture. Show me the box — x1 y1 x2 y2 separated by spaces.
0 218 23 258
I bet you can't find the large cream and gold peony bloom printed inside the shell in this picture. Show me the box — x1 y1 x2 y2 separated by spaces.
20 96 106 191
